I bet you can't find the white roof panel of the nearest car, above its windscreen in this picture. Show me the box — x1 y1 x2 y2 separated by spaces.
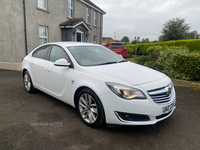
44 42 97 47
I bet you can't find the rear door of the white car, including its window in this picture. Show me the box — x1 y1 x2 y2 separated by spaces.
30 45 50 90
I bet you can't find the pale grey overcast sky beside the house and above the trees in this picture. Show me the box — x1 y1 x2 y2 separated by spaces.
91 0 200 41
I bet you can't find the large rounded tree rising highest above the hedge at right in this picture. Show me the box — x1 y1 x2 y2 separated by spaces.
162 18 190 41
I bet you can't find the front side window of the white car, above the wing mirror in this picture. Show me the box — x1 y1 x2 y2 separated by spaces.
49 46 69 62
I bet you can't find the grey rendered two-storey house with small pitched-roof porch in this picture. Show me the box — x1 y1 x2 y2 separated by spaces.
0 0 106 70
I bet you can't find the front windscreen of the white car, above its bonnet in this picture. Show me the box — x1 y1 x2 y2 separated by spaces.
67 46 126 66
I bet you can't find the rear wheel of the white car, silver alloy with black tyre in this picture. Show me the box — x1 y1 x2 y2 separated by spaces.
23 71 36 93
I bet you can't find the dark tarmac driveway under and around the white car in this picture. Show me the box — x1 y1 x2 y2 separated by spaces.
0 70 200 150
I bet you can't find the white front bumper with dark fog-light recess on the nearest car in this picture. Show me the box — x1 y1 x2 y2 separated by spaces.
100 78 176 125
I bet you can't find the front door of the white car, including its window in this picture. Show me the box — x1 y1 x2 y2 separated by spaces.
45 45 74 101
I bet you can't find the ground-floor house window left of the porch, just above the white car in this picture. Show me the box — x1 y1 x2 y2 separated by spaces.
39 26 48 45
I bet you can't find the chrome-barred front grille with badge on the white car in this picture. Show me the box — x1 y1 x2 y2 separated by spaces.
148 84 175 104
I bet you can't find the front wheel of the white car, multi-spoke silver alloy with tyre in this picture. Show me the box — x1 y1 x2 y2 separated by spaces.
76 89 105 127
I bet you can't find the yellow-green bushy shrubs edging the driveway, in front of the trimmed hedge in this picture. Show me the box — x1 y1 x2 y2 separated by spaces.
146 46 200 80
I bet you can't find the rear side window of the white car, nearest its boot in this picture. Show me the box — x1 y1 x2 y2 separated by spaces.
32 45 49 60
